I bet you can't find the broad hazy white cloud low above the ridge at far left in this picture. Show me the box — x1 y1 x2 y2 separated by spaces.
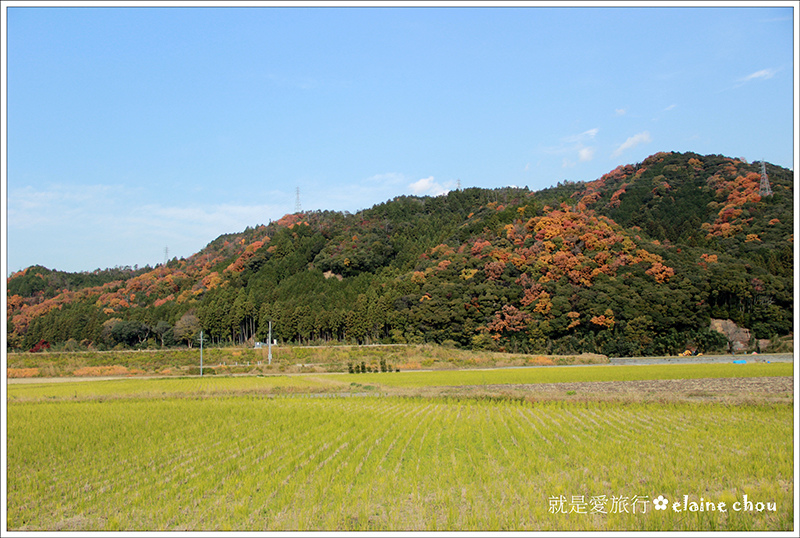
7 184 287 271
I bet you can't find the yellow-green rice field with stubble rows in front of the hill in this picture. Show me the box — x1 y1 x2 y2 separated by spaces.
6 363 796 531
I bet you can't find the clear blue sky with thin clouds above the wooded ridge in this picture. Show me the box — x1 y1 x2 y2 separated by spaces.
3 2 797 273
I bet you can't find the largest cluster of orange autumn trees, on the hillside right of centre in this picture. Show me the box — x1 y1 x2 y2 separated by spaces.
471 204 675 341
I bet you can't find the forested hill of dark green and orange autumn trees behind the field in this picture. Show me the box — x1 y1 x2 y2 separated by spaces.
7 153 793 356
